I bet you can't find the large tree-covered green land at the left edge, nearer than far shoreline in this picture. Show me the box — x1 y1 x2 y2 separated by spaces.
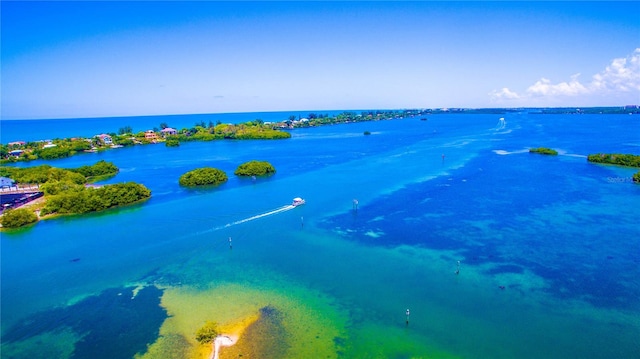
0 160 151 228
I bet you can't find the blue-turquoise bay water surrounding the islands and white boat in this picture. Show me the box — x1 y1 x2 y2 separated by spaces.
1 113 640 358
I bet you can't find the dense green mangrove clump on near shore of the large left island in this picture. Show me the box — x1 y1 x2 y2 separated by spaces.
41 182 151 215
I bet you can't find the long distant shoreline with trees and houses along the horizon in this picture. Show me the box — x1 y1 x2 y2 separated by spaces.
0 106 640 164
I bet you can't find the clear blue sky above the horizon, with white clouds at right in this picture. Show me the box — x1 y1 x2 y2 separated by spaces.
0 1 640 119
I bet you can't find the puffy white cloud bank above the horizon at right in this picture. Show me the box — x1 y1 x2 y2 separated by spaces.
490 48 640 102
